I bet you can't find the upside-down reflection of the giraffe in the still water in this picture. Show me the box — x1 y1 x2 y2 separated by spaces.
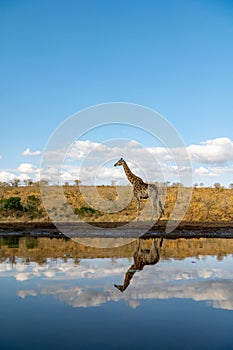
114 238 163 292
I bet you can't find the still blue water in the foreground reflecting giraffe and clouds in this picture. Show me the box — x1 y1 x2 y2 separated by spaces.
0 237 233 350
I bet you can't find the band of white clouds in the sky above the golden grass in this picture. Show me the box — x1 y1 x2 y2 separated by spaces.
0 137 233 185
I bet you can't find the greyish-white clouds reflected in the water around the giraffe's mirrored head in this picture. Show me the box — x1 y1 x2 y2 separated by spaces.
11 257 233 310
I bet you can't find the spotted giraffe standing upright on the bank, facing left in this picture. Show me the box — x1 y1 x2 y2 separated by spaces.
114 158 164 219
